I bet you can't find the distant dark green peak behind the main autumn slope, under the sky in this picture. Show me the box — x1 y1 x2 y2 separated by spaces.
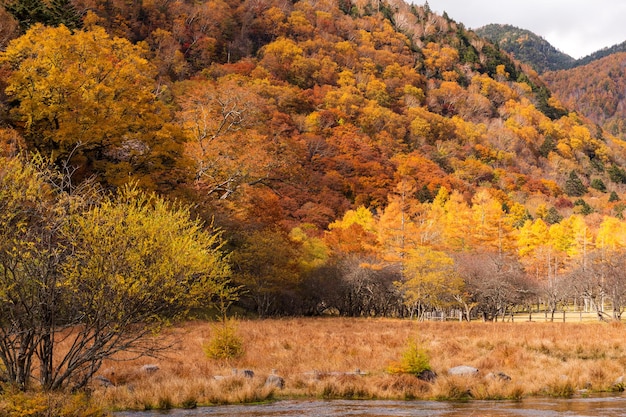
475 24 576 73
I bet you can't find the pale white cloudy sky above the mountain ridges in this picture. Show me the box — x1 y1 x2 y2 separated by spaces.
422 0 626 58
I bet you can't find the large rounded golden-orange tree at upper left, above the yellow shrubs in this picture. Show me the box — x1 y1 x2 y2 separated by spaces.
0 25 186 187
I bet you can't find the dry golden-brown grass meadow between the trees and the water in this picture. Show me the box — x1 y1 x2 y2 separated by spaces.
92 318 626 409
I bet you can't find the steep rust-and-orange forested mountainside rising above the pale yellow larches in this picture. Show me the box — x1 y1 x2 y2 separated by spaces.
1 0 624 224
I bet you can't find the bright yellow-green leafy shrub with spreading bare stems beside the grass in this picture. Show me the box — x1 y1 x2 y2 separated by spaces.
59 186 232 389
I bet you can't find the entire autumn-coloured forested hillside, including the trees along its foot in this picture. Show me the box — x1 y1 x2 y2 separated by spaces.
0 0 626 318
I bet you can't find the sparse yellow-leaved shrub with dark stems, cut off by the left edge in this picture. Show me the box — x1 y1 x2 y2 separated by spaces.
0 157 67 389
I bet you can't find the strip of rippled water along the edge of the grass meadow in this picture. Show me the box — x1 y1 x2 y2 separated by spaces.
115 397 626 417
